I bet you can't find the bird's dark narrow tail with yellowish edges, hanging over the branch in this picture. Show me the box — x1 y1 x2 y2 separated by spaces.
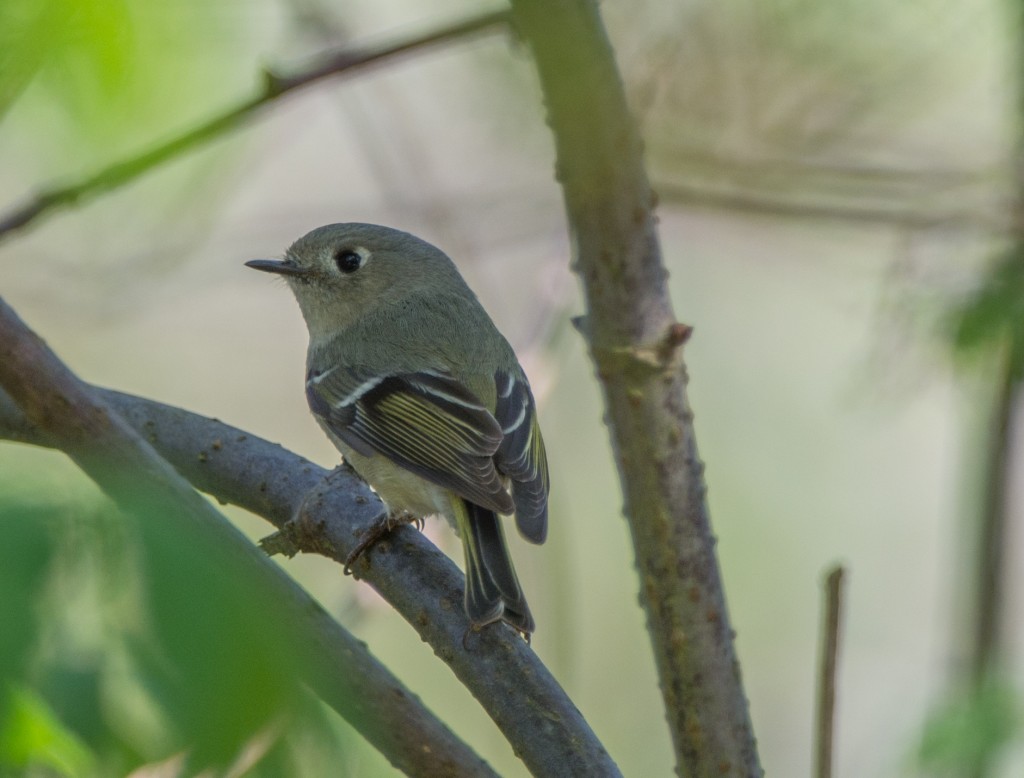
457 500 535 636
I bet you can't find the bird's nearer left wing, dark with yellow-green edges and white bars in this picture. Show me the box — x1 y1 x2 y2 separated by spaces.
306 368 514 513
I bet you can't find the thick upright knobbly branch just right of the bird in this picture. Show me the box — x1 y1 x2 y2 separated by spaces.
512 0 762 776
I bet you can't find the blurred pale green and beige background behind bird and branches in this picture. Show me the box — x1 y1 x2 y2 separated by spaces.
0 0 1024 776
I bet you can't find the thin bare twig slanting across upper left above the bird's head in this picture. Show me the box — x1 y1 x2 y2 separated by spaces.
0 10 509 240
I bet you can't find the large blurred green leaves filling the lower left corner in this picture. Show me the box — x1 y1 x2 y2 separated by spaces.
0 501 347 776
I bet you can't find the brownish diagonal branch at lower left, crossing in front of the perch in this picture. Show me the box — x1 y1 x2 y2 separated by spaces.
0 299 495 776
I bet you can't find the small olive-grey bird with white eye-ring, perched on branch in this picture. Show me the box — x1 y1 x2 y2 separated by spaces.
246 223 549 638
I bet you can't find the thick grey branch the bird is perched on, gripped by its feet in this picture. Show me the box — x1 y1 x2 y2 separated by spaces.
0 358 618 776
